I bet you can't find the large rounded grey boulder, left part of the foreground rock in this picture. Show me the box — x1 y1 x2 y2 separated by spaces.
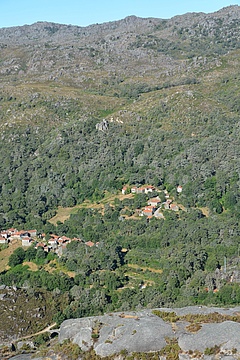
59 311 173 356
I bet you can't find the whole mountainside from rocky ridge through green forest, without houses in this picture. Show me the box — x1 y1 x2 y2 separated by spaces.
0 6 240 348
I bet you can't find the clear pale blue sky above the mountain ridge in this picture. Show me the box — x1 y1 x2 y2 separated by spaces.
0 0 240 28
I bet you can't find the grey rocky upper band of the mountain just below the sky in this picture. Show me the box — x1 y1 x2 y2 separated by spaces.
0 6 239 84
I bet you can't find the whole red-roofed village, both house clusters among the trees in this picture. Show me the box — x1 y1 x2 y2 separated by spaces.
0 185 182 257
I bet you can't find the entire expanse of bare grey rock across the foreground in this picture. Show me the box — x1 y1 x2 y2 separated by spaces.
59 307 240 359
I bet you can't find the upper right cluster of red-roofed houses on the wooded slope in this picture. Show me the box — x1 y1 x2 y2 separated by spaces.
122 185 183 218
